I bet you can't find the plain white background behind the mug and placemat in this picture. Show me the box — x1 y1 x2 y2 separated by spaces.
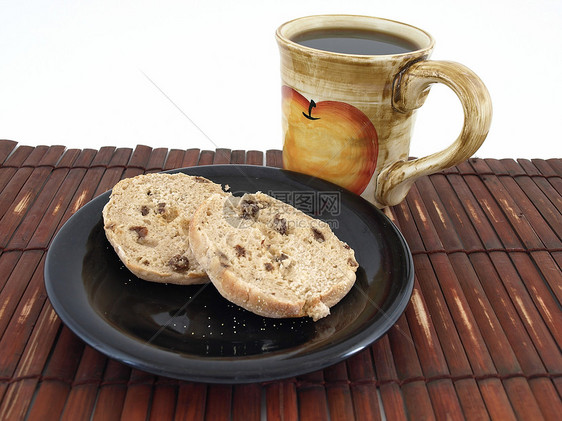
0 0 562 158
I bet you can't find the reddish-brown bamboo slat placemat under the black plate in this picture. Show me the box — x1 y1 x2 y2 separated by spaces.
0 141 562 421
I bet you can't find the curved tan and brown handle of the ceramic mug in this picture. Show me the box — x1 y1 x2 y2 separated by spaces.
375 60 492 206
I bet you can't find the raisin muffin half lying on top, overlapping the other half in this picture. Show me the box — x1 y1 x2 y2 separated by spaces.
189 193 358 321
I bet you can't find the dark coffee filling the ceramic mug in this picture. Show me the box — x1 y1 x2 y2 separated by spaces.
292 29 419 55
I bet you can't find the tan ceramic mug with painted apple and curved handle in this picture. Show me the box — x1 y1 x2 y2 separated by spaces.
276 15 492 207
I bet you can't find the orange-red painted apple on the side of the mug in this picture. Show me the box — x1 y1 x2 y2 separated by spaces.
282 86 378 194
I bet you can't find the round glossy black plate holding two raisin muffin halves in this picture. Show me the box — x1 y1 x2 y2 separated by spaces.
45 165 414 383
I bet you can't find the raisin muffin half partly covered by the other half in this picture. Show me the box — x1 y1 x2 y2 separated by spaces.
103 173 226 285
